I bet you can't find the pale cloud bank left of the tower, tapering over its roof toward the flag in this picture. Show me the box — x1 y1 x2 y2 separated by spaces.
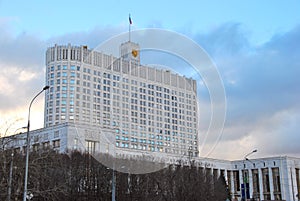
0 22 126 134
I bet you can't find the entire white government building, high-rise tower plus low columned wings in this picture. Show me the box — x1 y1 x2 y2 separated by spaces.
1 42 300 201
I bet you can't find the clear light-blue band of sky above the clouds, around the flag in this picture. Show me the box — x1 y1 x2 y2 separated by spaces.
0 0 300 43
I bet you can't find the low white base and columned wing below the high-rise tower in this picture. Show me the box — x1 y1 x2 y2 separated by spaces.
0 123 300 201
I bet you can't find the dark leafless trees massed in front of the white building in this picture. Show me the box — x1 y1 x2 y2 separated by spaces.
0 150 228 201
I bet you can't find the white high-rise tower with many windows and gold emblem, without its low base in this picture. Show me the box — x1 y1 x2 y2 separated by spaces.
44 42 199 155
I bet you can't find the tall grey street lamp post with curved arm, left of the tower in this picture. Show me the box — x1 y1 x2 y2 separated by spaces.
23 86 50 201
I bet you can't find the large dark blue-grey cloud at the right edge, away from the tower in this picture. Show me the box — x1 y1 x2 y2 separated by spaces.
225 25 300 124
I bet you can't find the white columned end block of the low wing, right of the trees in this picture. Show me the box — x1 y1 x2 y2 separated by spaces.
227 156 300 201
